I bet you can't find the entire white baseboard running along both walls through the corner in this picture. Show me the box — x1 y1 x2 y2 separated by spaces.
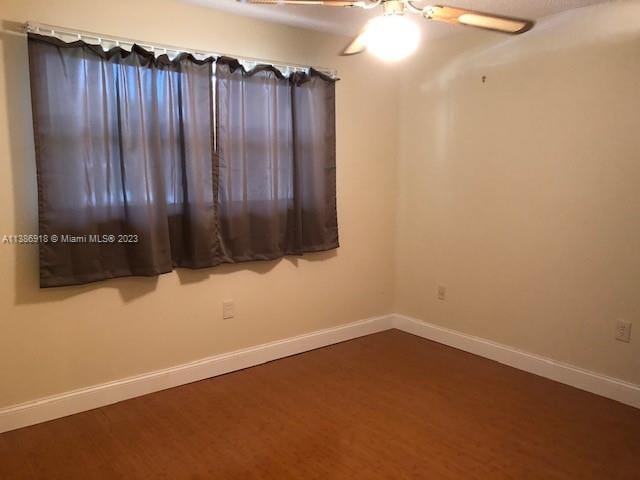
0 314 640 433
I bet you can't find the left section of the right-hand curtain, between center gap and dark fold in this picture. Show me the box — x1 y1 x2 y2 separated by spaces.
216 60 298 261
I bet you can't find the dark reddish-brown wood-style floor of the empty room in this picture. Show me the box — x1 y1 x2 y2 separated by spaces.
0 330 640 480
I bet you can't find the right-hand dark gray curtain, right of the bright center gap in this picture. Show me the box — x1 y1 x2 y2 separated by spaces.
216 58 338 261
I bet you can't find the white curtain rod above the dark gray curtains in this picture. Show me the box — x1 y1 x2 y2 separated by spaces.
25 22 338 78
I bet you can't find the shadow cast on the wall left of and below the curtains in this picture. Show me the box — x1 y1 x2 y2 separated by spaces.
0 20 337 305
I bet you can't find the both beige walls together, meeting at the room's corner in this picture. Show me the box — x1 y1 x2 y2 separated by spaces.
0 0 640 407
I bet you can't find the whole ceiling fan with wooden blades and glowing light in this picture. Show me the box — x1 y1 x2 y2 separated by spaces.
238 0 534 61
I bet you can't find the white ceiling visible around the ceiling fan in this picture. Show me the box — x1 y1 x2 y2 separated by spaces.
186 0 613 37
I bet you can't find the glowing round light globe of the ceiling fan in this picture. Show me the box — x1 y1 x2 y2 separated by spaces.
363 15 420 62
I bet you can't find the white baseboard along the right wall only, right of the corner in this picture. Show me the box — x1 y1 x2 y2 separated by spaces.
393 314 640 408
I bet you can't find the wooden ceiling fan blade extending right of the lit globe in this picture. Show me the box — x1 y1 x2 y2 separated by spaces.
422 5 534 35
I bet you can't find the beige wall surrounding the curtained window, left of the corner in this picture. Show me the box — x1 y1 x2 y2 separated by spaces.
0 0 396 406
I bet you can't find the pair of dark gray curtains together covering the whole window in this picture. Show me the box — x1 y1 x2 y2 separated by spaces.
28 34 338 287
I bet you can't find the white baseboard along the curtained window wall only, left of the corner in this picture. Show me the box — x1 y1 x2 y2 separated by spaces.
0 315 393 433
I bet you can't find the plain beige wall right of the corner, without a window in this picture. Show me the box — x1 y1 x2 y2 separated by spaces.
396 2 640 384
